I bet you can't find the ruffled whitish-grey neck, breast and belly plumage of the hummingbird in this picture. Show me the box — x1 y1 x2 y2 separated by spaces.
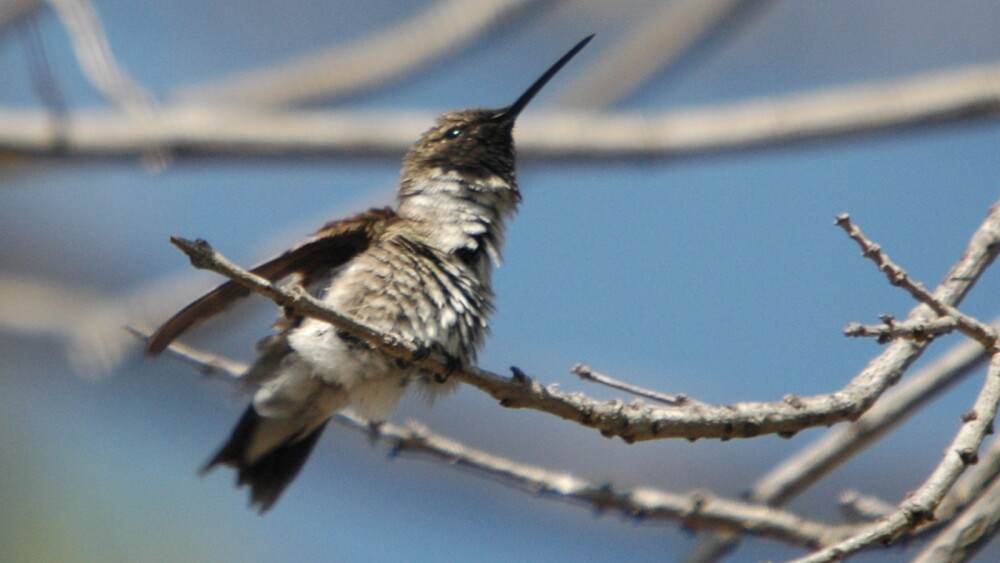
278 170 517 420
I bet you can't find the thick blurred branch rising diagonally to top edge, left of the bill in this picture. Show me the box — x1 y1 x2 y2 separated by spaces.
173 0 542 106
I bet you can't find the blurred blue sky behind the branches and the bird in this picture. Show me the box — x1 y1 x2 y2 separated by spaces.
0 0 1000 561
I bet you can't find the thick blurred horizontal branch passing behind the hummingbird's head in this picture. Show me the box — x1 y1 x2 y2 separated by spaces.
0 65 1000 158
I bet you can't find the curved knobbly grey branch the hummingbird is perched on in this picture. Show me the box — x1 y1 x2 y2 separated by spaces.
162 200 1000 448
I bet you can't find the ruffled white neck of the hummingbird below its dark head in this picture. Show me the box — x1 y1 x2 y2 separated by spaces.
396 169 520 265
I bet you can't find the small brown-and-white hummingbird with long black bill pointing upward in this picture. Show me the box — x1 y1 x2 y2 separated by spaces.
146 35 594 514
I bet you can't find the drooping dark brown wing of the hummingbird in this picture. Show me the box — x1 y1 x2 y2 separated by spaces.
146 207 395 355
